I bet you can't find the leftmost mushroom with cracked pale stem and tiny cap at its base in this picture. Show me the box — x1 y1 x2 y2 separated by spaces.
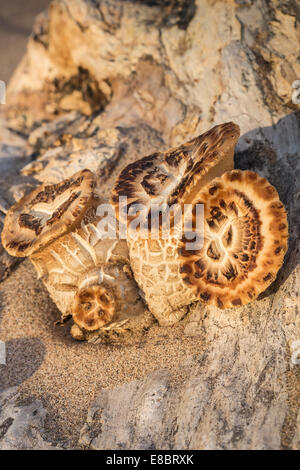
2 170 144 338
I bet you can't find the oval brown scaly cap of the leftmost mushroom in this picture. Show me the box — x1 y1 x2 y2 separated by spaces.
2 170 95 257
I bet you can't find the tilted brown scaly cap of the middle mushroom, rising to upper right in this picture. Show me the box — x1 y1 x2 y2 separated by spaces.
112 122 240 223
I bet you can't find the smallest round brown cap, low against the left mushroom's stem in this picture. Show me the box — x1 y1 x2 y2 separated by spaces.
72 286 116 331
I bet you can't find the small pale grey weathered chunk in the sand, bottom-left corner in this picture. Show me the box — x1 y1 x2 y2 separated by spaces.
0 387 59 450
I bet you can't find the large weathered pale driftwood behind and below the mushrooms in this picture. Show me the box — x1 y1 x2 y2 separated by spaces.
0 0 300 449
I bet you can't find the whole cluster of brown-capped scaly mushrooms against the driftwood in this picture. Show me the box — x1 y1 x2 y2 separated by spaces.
2 122 288 338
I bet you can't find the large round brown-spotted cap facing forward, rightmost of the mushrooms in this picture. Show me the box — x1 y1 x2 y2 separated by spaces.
179 170 288 308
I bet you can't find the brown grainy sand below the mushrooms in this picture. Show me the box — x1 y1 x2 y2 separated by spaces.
0 260 202 448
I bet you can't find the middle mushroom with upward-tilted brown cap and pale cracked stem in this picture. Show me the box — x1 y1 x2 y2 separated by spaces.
112 122 239 325
